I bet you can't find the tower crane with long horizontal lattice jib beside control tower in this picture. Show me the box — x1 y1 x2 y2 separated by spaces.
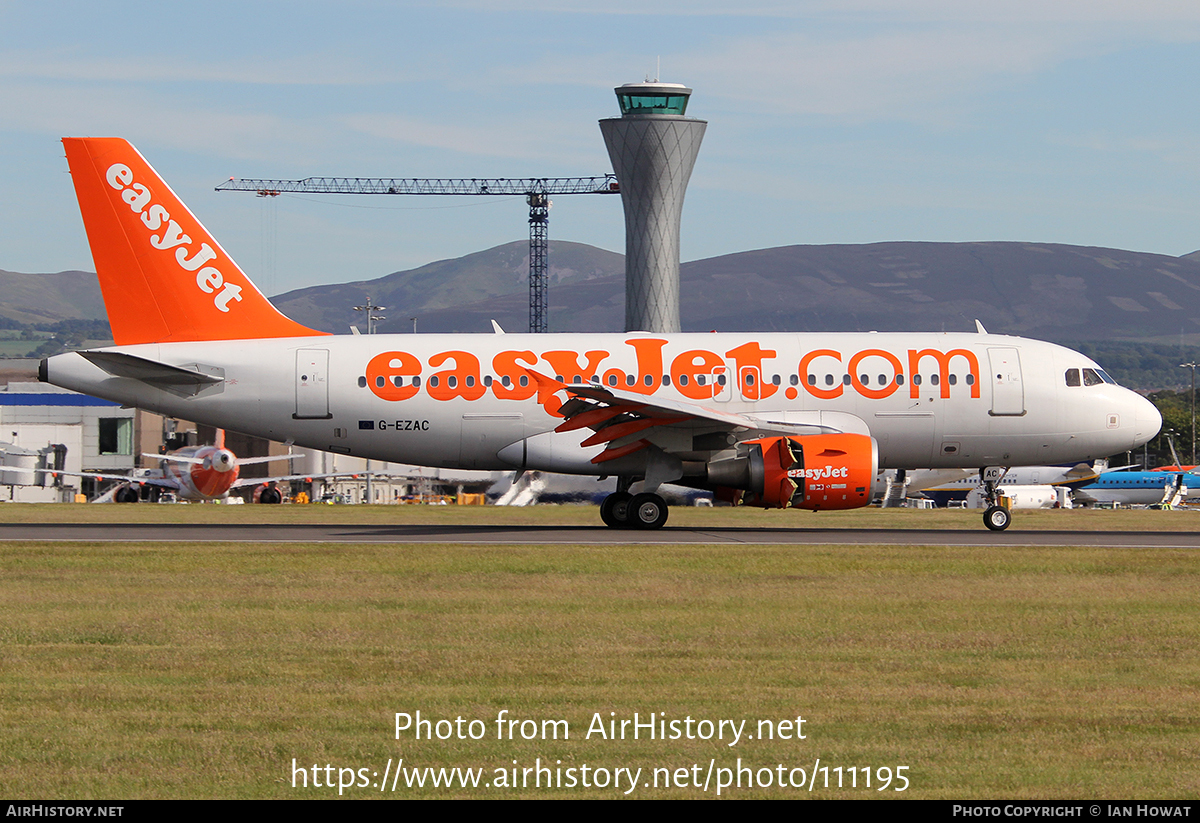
217 174 620 334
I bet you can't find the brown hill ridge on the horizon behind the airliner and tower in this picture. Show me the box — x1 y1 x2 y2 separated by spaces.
14 241 1200 346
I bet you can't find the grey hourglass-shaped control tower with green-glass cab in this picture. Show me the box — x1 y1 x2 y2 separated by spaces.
600 82 708 334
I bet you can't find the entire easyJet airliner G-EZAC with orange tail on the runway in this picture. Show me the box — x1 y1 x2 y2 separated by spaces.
40 138 1162 529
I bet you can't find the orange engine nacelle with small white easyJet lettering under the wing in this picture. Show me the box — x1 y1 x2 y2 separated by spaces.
718 434 880 510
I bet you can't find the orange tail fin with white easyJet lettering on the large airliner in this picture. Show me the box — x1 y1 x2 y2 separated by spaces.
62 137 324 346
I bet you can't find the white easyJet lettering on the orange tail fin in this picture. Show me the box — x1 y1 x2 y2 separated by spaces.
104 163 241 312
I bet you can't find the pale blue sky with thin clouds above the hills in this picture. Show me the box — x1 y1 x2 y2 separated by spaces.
0 0 1200 294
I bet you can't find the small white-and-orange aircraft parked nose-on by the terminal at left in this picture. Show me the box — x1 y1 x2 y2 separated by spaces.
36 428 312 503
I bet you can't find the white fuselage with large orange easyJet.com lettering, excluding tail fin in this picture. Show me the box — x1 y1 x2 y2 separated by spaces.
44 332 1162 475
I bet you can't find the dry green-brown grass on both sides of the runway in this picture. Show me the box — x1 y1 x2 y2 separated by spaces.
0 505 1200 799
